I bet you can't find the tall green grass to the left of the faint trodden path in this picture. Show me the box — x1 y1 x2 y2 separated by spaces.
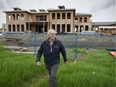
0 51 46 87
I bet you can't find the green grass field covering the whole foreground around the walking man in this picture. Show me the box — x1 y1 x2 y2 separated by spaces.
0 46 116 87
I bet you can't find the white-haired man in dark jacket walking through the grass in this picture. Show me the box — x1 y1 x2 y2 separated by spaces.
36 29 67 87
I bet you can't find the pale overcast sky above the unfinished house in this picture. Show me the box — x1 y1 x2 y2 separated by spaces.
0 0 116 27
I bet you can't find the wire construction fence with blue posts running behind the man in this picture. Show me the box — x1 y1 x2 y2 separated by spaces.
0 33 116 59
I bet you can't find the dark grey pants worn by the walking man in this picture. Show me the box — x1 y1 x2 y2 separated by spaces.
46 64 58 87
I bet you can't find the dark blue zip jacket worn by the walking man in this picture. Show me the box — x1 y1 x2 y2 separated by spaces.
36 39 67 64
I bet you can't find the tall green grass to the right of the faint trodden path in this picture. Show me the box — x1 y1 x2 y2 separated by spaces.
33 49 115 87
